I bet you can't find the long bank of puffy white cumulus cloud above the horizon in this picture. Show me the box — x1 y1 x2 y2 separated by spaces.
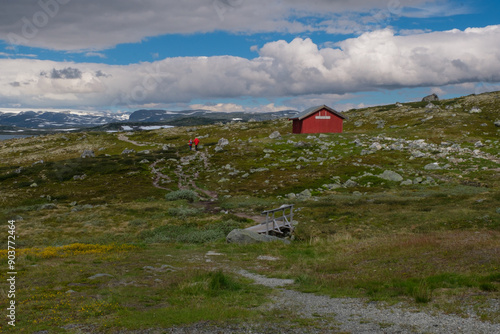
0 25 500 110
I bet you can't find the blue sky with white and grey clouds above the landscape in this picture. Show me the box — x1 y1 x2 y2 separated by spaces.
0 0 500 112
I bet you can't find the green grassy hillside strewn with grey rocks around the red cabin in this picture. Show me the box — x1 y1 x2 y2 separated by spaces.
0 92 500 332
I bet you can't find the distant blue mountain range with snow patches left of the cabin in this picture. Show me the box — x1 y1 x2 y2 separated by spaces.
0 110 297 130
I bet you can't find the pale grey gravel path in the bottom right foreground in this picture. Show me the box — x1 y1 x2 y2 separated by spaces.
238 270 500 334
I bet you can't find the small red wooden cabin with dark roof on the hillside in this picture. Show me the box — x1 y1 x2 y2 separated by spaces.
290 105 345 133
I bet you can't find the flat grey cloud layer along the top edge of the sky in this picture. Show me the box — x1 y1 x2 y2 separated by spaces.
0 0 458 50
